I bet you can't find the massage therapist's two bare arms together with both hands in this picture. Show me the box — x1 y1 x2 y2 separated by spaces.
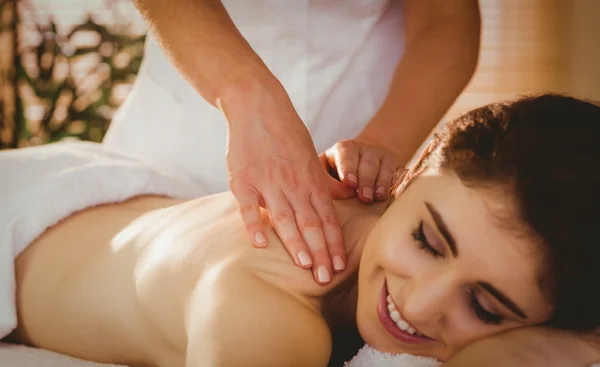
134 0 480 284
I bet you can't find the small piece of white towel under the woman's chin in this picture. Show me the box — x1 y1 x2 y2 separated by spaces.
345 345 441 367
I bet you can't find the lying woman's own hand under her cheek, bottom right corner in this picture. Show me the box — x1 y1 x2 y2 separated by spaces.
443 327 600 367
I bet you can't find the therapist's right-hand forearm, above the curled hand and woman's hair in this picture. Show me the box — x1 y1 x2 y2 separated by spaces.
357 13 479 166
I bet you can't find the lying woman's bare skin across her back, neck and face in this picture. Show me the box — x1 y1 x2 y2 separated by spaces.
7 168 597 367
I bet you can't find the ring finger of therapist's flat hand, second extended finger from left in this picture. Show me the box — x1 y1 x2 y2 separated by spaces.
264 187 313 269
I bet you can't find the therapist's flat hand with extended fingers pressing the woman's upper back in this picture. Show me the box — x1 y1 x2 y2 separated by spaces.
218 80 354 284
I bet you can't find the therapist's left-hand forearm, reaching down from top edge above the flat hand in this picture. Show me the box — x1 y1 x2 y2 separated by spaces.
134 0 279 106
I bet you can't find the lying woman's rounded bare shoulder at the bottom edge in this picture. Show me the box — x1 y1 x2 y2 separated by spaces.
186 266 331 366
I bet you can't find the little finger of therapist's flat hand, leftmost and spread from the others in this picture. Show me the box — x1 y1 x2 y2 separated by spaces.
230 181 267 247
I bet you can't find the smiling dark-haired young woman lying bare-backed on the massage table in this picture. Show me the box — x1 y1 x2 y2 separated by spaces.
4 95 600 367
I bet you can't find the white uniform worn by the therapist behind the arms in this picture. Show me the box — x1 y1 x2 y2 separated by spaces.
104 0 404 193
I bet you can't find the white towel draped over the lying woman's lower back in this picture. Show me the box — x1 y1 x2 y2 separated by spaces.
0 142 203 339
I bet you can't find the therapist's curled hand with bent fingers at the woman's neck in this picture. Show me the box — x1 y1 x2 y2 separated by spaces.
320 139 400 203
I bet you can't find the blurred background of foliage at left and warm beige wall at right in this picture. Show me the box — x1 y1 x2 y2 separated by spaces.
0 0 600 149
